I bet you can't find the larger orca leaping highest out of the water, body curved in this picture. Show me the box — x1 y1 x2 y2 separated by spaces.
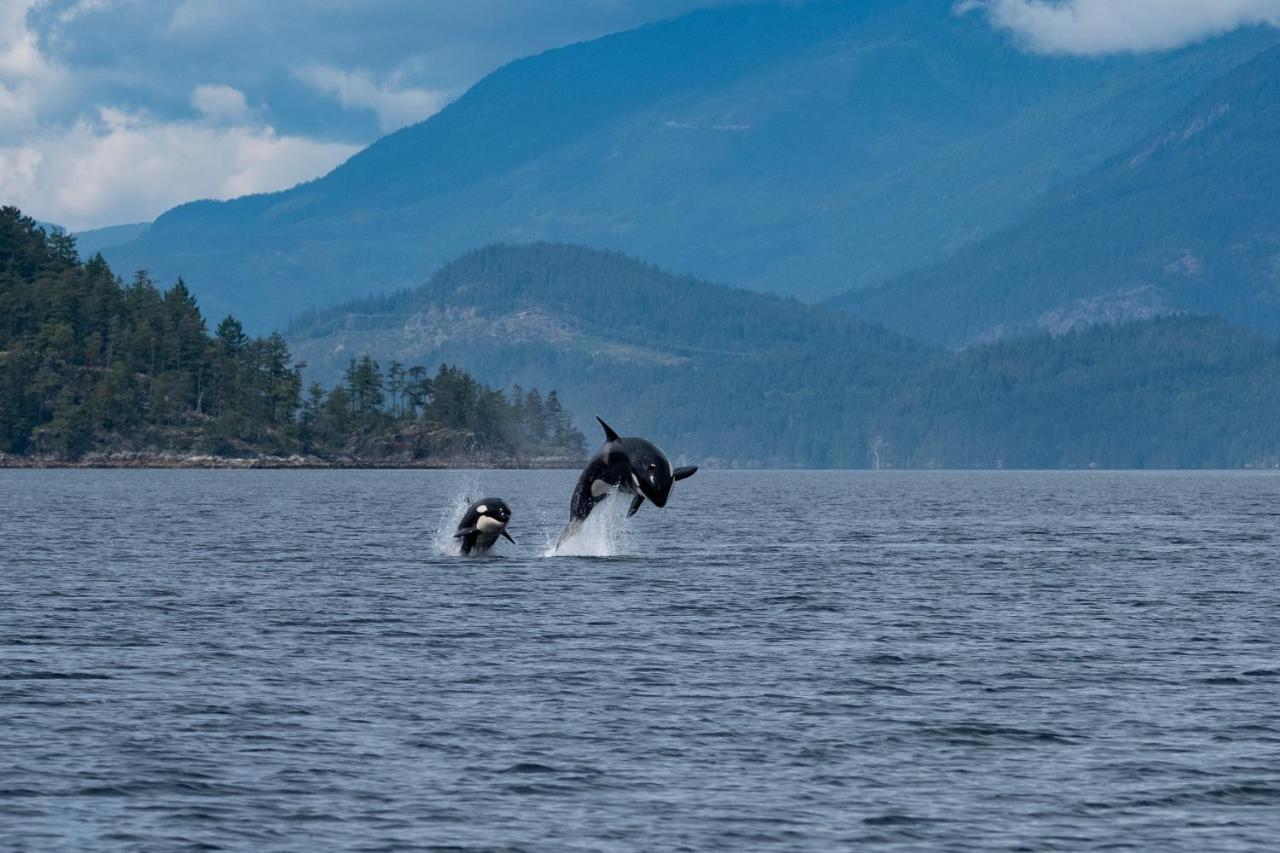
559 418 698 542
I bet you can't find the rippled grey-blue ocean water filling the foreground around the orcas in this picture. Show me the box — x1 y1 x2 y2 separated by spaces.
0 471 1280 850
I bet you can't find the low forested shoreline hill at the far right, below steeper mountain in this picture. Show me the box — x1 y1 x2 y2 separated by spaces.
872 316 1280 469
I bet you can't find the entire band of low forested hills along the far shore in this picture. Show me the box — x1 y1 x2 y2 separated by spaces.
288 243 1280 467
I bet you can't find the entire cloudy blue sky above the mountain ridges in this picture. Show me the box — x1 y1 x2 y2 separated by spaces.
0 0 1280 229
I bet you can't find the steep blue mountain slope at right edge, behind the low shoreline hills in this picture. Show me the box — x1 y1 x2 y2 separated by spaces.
832 41 1280 346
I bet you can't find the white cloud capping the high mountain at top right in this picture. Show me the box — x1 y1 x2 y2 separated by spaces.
956 0 1280 56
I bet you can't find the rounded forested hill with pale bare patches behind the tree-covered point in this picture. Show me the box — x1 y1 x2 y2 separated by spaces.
288 243 927 466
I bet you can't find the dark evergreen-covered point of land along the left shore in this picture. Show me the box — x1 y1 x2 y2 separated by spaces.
0 207 584 461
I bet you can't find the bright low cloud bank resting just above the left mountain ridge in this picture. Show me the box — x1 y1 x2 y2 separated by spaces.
0 109 358 229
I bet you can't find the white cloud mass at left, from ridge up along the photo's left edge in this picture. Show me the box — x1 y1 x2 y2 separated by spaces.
0 0 358 229
